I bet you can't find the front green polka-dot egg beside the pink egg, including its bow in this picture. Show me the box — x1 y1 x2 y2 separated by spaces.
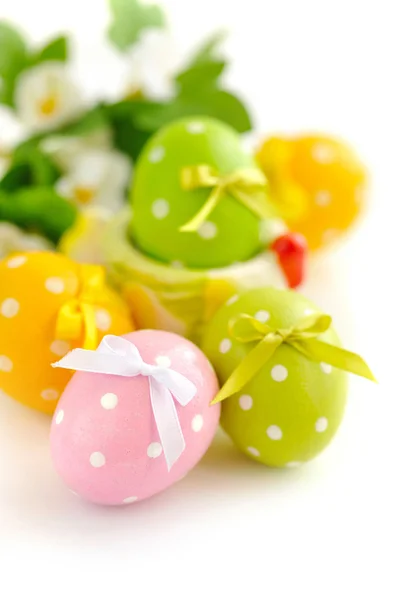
202 288 373 467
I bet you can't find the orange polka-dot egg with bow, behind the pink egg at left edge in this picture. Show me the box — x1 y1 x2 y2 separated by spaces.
0 252 133 414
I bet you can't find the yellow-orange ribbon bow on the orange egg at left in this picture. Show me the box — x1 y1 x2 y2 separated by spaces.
55 265 106 350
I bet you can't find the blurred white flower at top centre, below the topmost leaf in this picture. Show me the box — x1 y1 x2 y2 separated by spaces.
127 28 179 100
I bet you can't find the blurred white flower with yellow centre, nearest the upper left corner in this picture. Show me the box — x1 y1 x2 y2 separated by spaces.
15 61 83 131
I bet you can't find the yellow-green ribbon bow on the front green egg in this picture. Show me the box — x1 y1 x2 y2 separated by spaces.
211 314 375 404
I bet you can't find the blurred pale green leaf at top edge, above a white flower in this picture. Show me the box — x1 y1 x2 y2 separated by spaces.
108 0 165 50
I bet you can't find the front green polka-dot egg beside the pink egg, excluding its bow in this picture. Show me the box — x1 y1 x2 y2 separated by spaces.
202 288 347 467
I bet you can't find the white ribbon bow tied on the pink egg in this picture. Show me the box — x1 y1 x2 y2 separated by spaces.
52 335 197 471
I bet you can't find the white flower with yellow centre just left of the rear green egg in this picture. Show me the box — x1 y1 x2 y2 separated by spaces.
56 150 132 213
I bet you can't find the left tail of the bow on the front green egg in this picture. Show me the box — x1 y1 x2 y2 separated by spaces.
211 335 283 405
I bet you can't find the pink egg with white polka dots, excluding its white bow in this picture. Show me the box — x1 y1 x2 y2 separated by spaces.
51 330 220 505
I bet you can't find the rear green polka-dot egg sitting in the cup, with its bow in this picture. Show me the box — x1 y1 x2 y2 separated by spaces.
130 117 274 269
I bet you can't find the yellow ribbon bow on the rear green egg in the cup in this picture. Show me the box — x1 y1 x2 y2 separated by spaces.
179 165 273 232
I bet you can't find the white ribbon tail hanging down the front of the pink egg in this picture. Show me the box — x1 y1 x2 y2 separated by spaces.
149 376 186 471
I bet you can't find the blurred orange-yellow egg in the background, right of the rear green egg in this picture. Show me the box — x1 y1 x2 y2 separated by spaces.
257 135 367 250
